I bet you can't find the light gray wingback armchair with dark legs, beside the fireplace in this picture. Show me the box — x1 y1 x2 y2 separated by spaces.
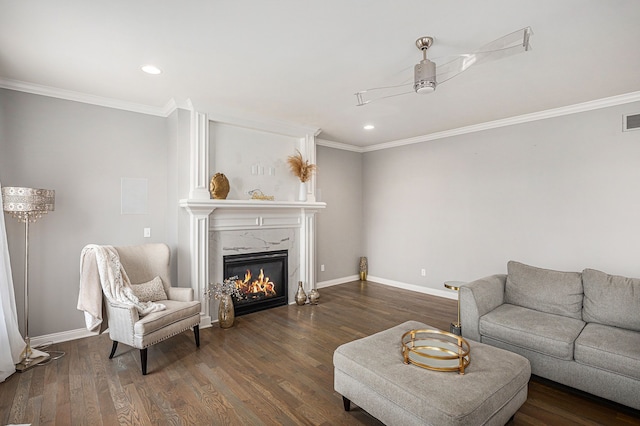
82 244 200 375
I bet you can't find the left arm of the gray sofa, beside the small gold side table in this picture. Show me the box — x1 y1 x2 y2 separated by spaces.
460 274 507 342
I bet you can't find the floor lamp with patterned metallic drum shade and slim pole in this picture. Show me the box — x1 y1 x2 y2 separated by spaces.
2 186 56 371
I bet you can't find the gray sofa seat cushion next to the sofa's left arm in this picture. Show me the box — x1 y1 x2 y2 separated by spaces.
480 303 585 361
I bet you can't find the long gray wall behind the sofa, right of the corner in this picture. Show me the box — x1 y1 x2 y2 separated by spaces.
364 103 640 289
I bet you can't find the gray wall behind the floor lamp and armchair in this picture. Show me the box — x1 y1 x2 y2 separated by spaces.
0 89 175 336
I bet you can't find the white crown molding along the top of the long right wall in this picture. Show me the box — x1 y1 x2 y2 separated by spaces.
362 91 640 152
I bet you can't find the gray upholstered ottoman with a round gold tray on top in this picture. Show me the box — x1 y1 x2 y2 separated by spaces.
333 321 531 426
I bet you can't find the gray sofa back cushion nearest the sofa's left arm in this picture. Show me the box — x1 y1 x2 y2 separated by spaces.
504 260 583 319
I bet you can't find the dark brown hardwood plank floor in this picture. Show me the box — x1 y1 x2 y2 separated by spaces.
0 282 640 425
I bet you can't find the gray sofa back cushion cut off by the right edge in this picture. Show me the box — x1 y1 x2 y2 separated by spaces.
582 269 640 331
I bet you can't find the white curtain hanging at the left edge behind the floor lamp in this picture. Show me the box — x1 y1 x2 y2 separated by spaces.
0 184 26 382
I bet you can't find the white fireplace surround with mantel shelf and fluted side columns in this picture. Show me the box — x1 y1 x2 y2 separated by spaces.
178 109 326 327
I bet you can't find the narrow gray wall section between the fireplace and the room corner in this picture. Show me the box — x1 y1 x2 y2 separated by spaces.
316 146 366 283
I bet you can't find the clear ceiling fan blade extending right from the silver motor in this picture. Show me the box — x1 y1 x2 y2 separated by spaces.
434 27 533 84
